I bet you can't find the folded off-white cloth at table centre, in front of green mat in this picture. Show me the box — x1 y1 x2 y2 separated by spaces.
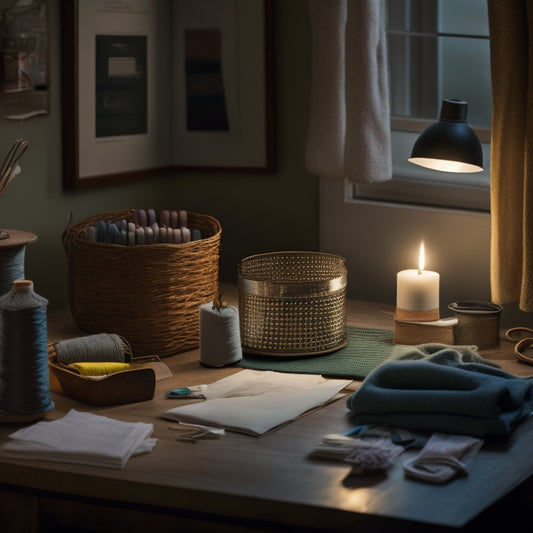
162 370 351 436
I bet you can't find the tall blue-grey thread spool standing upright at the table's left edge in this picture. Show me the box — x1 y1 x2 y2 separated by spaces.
0 280 54 418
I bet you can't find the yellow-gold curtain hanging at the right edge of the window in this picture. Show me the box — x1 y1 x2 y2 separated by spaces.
488 0 533 312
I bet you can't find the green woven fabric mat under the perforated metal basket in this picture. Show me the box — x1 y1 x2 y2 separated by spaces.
237 326 394 379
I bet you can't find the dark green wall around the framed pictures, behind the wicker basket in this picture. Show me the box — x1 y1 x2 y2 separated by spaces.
0 0 319 308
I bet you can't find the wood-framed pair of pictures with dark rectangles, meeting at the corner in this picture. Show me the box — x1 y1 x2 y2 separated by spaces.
61 0 275 189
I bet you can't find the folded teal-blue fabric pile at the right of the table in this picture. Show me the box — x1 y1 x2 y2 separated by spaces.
347 348 533 437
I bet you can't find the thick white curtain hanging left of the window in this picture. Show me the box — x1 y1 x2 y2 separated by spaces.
306 0 392 183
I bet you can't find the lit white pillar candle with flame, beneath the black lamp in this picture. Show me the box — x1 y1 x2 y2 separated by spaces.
396 242 440 321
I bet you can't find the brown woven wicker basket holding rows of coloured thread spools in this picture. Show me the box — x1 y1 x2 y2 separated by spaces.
63 209 221 357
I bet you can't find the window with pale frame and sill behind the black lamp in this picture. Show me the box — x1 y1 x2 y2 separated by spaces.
354 0 491 211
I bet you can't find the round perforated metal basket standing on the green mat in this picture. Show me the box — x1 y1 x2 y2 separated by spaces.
238 252 347 357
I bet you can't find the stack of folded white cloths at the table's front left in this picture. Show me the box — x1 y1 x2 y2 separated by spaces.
3 409 157 468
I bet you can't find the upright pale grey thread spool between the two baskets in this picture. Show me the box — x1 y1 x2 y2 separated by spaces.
200 302 242 367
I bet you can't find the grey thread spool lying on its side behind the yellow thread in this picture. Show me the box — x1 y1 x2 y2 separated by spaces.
55 333 129 365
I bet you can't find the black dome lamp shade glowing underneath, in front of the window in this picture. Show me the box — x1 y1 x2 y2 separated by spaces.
409 99 483 173
